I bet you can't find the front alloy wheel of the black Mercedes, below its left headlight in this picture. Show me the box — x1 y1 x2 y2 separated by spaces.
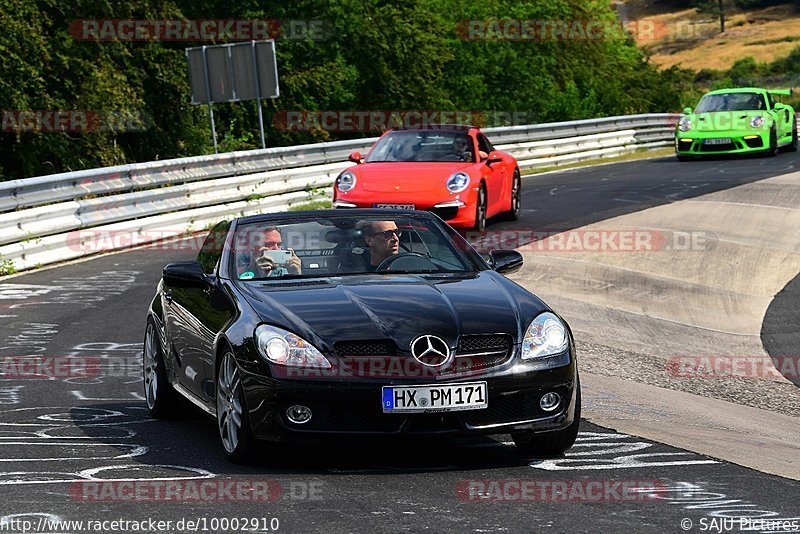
217 352 251 461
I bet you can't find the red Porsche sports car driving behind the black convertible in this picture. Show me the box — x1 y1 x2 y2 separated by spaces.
333 126 522 231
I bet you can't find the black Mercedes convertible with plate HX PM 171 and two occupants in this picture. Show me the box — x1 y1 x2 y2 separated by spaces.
143 209 581 461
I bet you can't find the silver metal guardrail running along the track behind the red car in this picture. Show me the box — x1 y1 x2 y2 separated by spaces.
0 114 677 272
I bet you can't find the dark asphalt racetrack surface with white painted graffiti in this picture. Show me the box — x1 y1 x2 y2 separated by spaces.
0 154 800 532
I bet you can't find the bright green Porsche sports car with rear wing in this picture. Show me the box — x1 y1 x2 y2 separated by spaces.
675 88 798 161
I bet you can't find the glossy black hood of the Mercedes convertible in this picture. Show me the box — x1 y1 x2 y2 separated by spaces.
240 271 549 351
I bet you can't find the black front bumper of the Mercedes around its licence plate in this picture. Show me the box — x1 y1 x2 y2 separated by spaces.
234 350 577 441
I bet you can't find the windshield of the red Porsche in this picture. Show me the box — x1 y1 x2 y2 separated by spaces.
367 131 475 163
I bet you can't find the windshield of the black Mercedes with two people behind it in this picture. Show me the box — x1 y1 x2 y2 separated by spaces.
231 215 475 280
